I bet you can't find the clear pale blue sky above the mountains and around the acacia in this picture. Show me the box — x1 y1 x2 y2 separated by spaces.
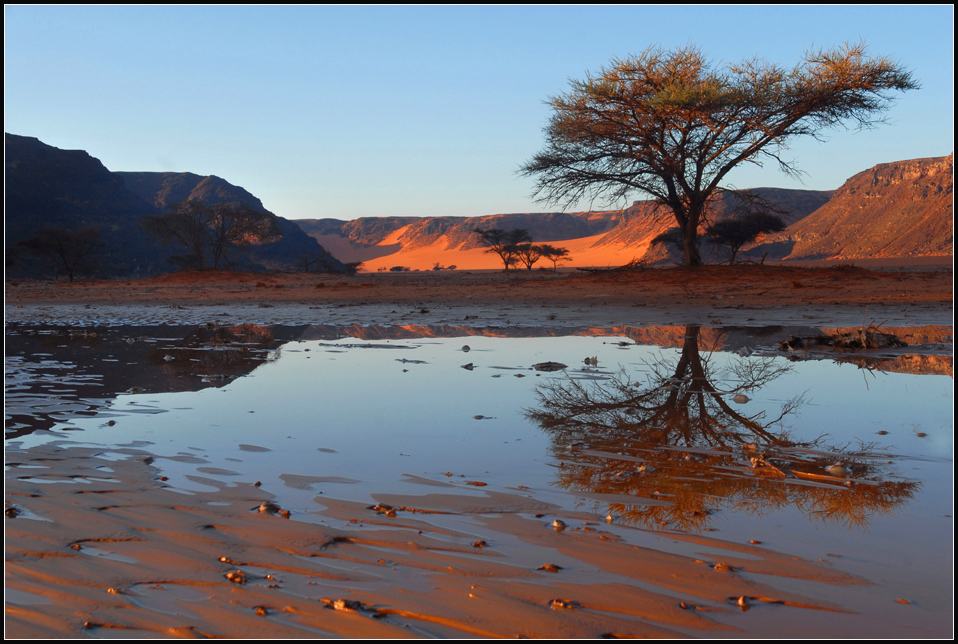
4 5 954 219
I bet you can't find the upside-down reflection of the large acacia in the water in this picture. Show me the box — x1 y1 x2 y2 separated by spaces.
527 326 917 530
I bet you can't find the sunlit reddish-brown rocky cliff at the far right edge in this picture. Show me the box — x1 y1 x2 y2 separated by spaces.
770 153 955 259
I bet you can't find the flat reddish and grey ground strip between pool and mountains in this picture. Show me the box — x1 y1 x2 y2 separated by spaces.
6 266 954 326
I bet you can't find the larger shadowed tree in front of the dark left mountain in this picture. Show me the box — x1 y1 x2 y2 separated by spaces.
143 200 280 270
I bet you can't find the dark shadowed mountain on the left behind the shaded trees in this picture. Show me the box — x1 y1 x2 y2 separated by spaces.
4 134 343 277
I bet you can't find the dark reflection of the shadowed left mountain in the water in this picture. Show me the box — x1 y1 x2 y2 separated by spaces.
4 324 302 438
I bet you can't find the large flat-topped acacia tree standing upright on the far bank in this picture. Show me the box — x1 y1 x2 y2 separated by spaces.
520 43 919 266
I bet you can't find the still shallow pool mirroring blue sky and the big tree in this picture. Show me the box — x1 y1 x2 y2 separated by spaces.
6 325 954 632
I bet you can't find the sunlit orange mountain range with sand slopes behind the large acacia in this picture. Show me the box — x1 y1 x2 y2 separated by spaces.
296 154 954 270
